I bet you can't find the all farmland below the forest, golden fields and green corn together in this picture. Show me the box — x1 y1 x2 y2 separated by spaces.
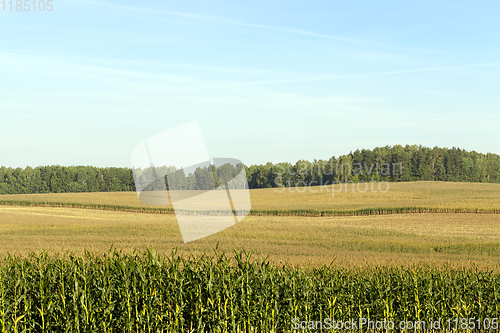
0 182 500 332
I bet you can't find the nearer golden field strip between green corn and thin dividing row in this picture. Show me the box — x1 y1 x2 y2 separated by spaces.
0 206 500 268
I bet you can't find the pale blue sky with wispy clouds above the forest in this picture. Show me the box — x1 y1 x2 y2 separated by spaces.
0 0 500 167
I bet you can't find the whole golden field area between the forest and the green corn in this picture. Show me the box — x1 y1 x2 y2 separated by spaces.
0 182 500 269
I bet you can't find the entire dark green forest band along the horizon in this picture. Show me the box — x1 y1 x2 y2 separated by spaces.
0 145 500 194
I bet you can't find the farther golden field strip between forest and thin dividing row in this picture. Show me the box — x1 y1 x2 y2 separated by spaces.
0 182 500 210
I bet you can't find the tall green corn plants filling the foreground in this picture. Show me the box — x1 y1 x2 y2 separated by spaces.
0 249 500 332
